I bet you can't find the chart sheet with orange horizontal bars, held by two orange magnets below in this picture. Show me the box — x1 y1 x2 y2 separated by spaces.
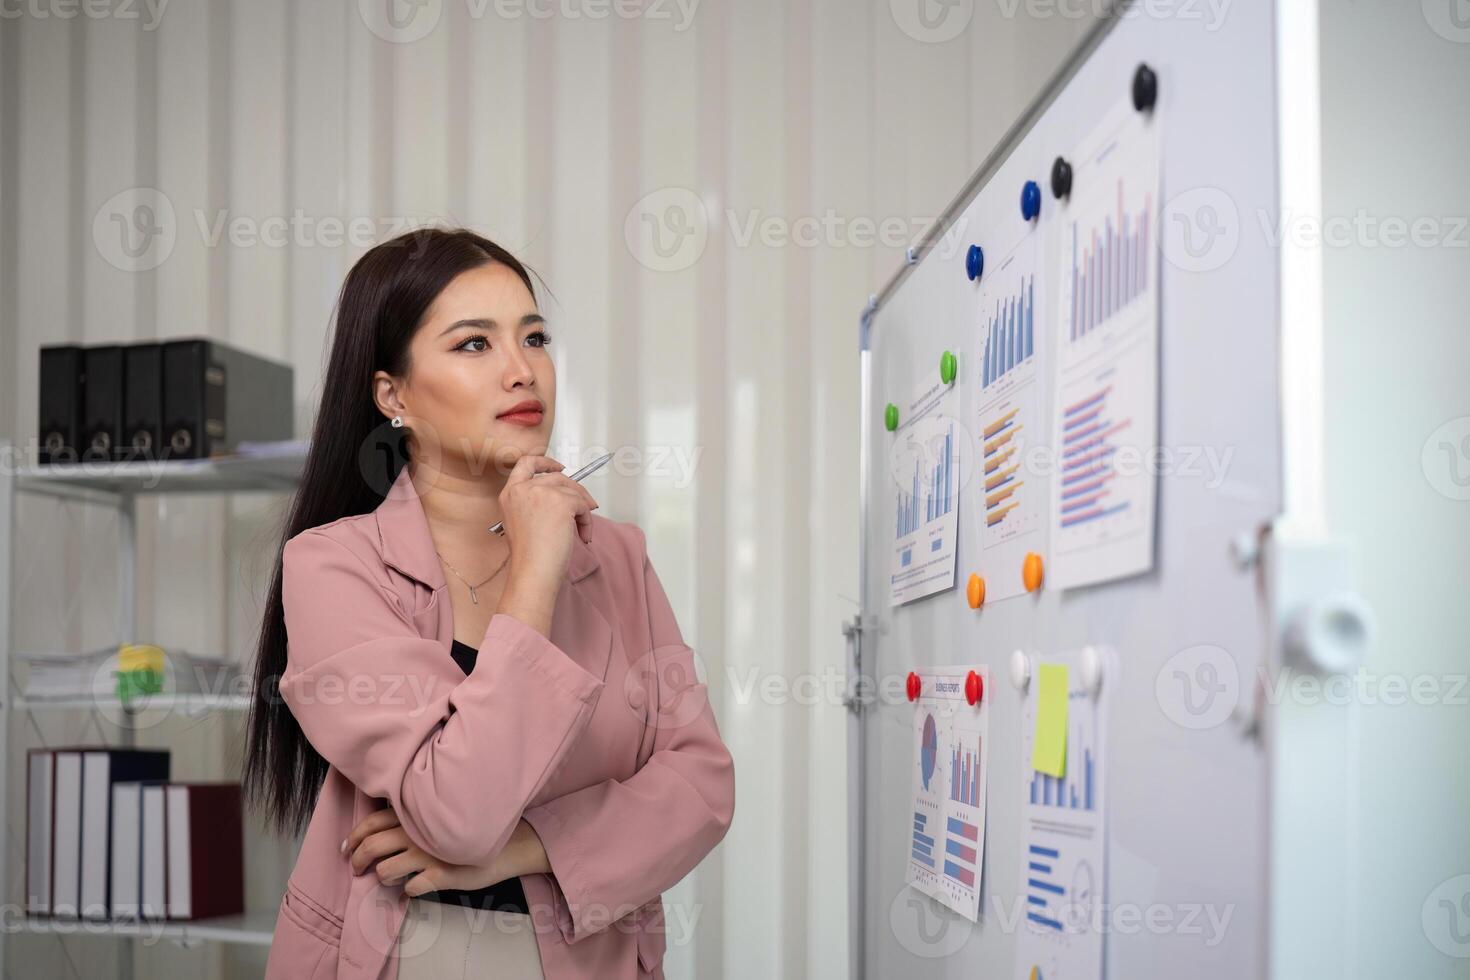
966 231 1050 602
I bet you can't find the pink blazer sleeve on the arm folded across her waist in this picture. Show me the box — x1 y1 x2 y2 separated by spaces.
523 526 735 943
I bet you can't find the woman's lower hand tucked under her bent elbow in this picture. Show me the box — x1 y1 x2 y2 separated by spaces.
341 807 551 896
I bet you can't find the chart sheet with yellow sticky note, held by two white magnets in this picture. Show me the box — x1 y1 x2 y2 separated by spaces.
1014 651 1117 980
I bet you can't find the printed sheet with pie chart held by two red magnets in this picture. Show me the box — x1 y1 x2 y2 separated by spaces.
904 666 989 923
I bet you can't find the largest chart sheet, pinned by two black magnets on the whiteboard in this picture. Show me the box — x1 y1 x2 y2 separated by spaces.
1047 103 1160 588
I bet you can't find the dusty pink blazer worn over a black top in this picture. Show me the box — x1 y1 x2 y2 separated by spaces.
266 467 735 980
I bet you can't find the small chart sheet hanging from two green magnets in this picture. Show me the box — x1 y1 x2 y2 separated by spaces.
889 373 973 605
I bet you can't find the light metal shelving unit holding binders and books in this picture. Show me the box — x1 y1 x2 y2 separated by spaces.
0 442 306 976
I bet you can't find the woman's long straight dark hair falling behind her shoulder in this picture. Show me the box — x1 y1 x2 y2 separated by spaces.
243 228 535 835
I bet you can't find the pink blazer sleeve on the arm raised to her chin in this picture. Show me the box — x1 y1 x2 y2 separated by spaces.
279 529 603 864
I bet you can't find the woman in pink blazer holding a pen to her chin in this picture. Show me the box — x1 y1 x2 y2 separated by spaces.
244 231 735 980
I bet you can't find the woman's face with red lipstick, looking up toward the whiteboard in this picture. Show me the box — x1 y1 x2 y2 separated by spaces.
379 262 556 476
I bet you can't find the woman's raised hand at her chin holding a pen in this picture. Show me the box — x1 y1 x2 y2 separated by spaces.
497 455 598 636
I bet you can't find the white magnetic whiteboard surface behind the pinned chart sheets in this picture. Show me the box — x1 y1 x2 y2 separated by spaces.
856 4 1282 980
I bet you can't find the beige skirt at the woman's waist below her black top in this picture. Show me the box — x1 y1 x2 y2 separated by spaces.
397 896 544 980
